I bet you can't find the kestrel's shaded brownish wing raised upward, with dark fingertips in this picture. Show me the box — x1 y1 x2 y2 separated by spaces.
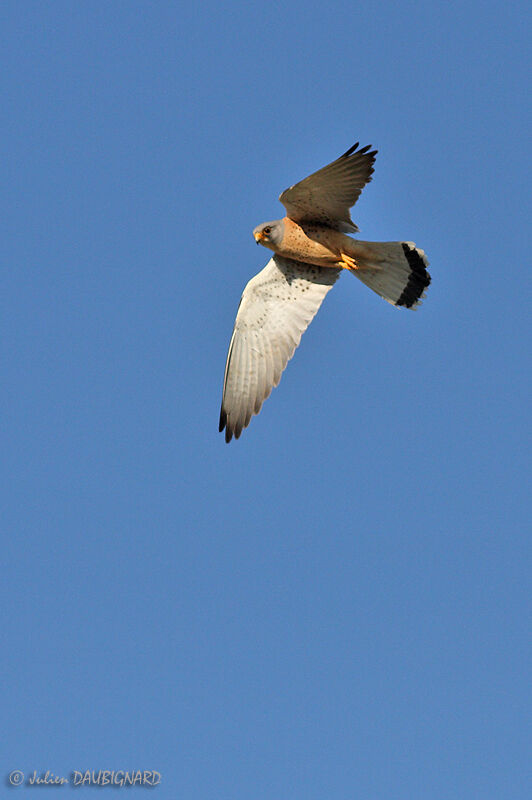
279 142 377 233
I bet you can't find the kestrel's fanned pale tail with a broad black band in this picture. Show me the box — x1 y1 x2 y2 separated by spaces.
349 239 430 308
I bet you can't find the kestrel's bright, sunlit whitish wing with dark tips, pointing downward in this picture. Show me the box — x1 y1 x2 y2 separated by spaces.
220 255 340 442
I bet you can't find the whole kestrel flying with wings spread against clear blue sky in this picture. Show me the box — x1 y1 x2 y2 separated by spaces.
219 142 431 442
